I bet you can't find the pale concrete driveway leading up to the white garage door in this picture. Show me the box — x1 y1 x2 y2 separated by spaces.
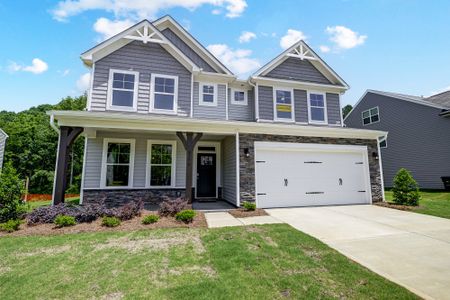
267 205 450 299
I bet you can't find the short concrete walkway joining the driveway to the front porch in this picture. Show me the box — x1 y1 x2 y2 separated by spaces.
205 212 282 228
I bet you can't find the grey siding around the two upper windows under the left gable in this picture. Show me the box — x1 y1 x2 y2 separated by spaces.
90 41 191 116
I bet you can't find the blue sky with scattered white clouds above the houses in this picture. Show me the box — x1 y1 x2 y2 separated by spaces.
0 0 450 111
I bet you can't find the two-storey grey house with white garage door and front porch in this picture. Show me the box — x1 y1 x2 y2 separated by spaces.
48 16 386 207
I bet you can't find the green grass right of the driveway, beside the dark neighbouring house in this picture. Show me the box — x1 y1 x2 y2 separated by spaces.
385 191 450 219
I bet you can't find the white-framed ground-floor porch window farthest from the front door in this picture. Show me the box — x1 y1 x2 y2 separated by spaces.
101 139 135 187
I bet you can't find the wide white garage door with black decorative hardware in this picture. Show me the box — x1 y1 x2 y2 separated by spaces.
255 142 371 208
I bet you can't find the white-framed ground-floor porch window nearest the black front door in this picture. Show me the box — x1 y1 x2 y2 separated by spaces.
147 141 176 187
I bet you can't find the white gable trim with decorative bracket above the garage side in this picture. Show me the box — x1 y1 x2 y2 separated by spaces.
252 40 350 89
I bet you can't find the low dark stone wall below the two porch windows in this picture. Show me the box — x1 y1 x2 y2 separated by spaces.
83 188 185 207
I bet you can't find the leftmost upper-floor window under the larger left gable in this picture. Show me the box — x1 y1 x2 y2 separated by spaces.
108 69 139 110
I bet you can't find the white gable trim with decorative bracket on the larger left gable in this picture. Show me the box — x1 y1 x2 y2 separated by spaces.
81 20 199 71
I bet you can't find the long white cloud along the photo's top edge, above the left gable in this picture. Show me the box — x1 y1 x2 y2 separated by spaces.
51 0 247 21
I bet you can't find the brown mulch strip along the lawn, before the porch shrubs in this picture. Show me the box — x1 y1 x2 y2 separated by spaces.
0 210 207 237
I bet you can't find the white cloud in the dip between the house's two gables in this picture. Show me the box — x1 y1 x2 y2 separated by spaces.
207 44 261 77
